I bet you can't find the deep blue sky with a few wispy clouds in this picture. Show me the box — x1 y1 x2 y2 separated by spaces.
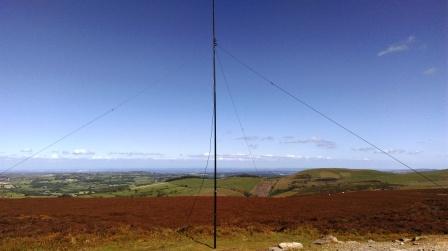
0 0 448 171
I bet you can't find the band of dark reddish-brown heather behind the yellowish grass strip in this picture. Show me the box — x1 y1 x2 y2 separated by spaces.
0 190 448 237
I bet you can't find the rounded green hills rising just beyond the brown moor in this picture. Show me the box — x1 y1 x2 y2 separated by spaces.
128 168 448 197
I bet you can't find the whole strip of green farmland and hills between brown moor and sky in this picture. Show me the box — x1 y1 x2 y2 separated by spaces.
0 168 448 198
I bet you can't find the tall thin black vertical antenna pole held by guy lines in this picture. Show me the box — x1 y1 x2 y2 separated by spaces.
212 0 217 249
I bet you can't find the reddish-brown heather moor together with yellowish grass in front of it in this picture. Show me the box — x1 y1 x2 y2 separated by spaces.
0 190 448 250
